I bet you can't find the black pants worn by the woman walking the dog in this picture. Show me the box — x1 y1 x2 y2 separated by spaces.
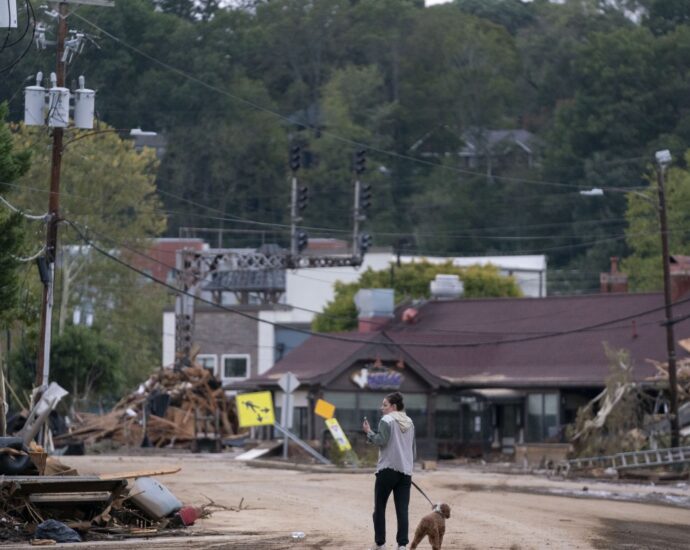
374 468 412 546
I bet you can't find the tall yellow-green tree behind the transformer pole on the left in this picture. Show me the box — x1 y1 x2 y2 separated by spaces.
11 127 167 390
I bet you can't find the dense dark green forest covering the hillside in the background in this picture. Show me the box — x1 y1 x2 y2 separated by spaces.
0 0 690 298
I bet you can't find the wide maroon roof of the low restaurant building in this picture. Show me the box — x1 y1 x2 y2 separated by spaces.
258 293 690 387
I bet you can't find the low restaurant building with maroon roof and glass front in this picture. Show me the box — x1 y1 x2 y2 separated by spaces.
250 272 690 456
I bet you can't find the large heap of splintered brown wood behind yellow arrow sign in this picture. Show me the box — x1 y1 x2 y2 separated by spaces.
55 366 239 451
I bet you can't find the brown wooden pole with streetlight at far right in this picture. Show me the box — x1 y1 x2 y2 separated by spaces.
655 149 680 447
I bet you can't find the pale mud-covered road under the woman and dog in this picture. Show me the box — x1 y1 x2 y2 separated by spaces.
2 453 690 550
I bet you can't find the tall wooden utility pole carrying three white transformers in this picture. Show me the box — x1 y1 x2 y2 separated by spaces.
34 2 67 388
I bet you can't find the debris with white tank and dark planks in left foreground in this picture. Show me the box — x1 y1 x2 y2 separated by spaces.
0 468 224 546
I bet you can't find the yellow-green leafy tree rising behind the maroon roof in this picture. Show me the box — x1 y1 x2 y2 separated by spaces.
312 261 521 332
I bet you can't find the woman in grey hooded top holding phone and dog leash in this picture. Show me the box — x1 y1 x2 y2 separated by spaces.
362 392 416 550
